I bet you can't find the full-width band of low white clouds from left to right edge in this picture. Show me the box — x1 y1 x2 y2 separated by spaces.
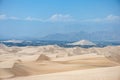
0 14 120 23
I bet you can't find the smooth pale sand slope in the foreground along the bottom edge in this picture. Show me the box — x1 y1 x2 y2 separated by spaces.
6 66 120 80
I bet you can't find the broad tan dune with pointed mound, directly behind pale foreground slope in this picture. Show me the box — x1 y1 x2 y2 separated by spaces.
1 54 120 78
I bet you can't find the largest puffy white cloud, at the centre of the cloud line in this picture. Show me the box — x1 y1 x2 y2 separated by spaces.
48 14 74 22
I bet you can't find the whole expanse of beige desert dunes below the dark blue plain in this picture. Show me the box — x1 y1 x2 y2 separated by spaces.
0 45 120 80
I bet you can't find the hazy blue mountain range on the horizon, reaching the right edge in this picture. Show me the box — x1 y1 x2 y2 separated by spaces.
40 31 120 41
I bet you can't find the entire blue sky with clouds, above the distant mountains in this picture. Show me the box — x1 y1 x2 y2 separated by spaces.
0 0 120 39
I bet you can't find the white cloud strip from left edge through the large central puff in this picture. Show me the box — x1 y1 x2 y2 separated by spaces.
0 14 75 22
